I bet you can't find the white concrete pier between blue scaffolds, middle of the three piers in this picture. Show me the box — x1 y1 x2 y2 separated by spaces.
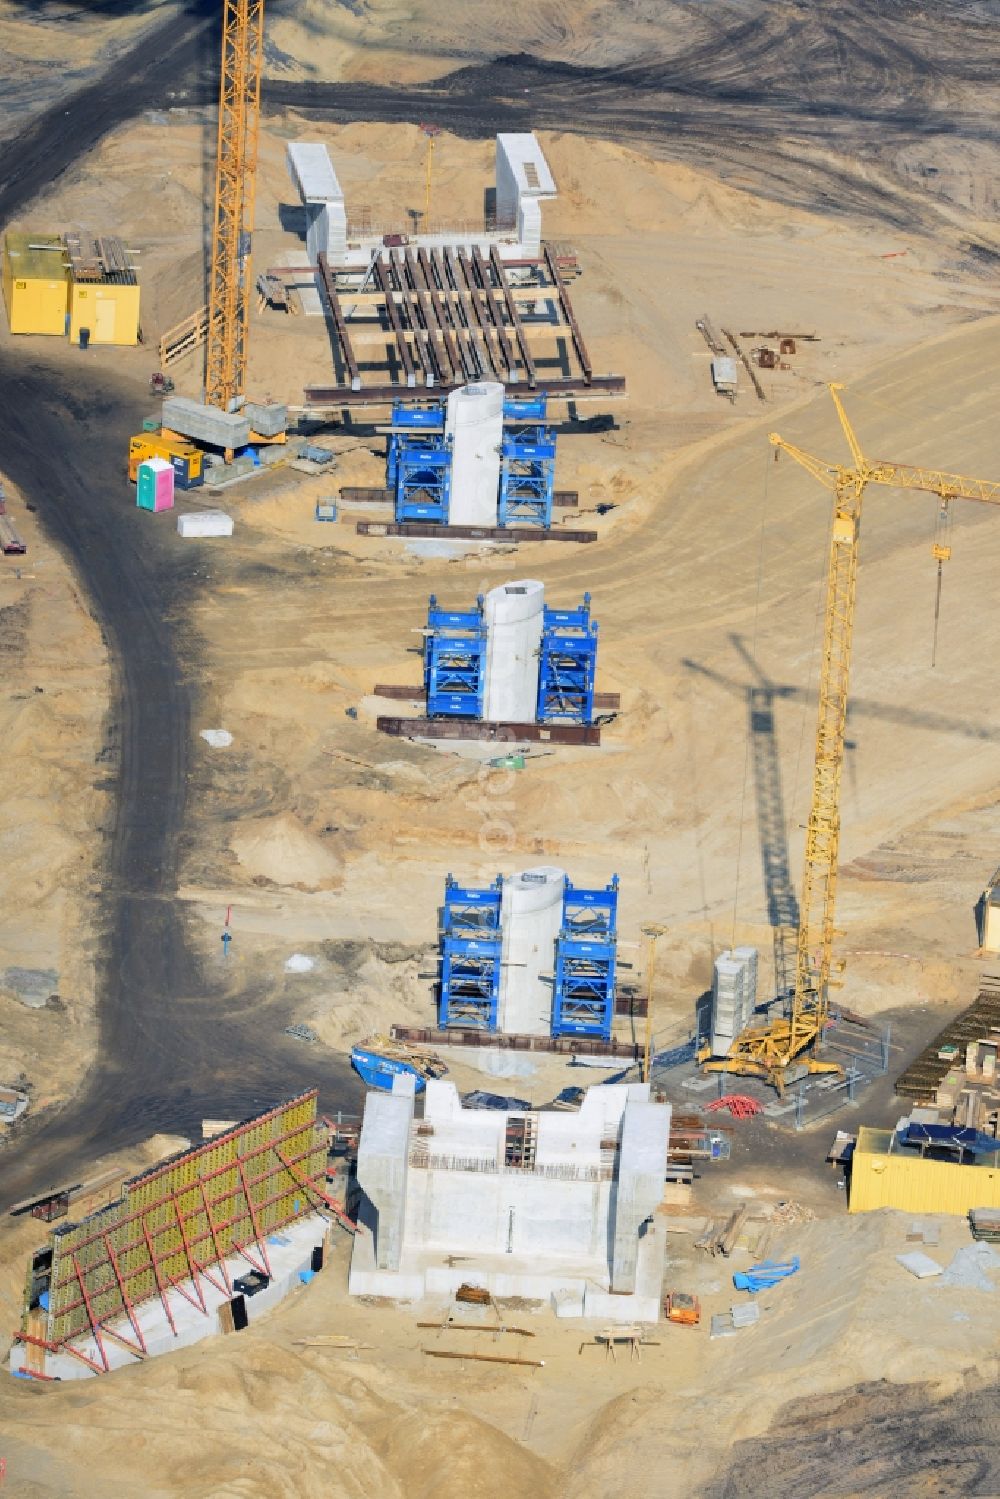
483 577 546 724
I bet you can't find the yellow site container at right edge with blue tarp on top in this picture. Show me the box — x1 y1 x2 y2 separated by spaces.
850 1126 1000 1217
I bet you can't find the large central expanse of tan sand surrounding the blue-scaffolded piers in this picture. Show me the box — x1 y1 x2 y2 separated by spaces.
5 111 1000 1127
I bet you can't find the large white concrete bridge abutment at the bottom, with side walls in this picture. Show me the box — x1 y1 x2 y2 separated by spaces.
349 1079 670 1322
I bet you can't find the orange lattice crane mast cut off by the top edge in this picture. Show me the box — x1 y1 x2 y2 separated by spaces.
205 0 264 411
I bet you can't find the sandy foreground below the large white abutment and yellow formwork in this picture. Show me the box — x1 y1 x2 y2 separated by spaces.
0 1142 1000 1499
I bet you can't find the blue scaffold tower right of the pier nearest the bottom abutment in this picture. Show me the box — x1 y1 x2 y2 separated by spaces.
552 875 618 1040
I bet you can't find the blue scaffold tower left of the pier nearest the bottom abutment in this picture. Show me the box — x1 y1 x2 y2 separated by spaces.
438 875 502 1031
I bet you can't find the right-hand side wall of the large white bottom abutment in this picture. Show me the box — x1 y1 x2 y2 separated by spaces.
612 1099 670 1294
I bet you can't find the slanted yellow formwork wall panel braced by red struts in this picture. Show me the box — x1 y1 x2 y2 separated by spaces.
41 1093 325 1342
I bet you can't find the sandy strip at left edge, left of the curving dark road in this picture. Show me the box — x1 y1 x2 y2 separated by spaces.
0 486 109 1139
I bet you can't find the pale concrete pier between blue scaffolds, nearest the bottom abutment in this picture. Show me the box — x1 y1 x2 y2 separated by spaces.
498 865 567 1036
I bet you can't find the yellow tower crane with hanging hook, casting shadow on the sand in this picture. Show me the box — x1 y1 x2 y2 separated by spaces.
708 385 1000 1093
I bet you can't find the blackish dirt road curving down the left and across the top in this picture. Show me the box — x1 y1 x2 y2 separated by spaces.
0 0 997 1204
